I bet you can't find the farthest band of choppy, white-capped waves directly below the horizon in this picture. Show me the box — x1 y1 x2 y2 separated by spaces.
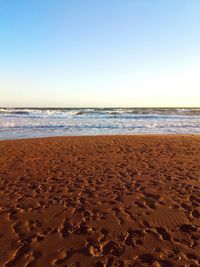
0 108 200 119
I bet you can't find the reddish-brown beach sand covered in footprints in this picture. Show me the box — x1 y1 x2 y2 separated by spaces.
0 135 200 267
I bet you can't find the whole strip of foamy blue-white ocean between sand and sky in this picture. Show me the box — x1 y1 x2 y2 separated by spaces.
0 108 200 140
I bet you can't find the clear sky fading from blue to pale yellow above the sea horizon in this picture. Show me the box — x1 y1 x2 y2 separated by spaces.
0 0 200 107
